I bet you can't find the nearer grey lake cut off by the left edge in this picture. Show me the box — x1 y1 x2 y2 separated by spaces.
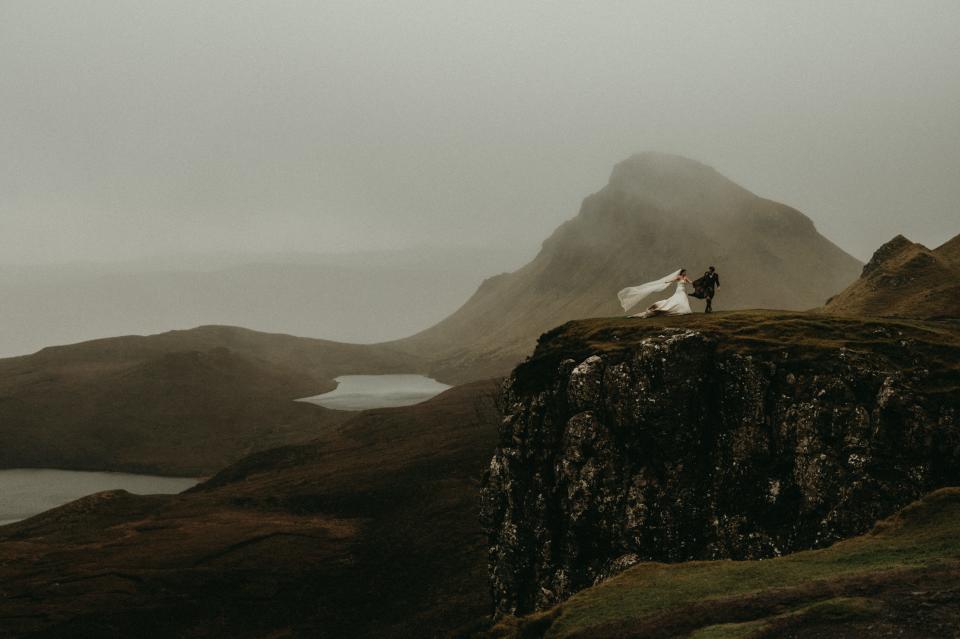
0 468 197 526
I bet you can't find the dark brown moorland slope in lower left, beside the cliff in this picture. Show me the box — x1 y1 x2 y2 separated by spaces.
0 382 499 639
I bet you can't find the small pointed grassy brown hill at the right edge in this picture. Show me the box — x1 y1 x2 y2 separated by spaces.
823 235 960 319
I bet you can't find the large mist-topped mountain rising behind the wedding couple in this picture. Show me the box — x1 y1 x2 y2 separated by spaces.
398 153 860 379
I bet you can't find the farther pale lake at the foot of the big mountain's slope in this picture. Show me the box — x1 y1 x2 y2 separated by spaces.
297 374 450 410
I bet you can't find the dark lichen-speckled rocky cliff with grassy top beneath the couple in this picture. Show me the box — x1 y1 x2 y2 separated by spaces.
482 313 960 613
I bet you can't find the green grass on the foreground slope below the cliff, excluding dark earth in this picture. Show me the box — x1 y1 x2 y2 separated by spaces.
492 488 960 639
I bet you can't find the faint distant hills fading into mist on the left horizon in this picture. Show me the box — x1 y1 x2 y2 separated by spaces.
0 248 526 356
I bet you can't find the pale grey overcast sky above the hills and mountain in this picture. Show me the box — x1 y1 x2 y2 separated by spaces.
0 0 960 263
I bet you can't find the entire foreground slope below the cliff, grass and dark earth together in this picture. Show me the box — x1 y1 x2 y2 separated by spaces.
488 488 960 639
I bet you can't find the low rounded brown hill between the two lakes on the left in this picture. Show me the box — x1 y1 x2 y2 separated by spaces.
0 326 425 475
